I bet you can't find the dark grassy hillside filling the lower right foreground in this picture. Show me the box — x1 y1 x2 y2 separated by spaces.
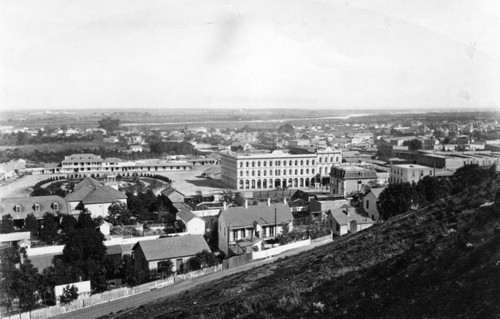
107 181 500 318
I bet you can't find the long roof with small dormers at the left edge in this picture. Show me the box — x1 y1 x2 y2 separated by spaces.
0 195 67 219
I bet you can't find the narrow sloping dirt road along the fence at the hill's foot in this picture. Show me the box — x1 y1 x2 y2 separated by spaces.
53 240 332 319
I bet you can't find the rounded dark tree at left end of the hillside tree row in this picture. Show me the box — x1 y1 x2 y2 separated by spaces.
377 183 413 220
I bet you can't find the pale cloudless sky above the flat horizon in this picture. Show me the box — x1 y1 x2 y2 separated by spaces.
0 0 500 110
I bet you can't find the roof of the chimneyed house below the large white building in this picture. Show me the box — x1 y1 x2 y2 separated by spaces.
219 203 293 228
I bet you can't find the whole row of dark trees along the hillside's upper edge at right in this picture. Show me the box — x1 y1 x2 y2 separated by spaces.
376 165 497 220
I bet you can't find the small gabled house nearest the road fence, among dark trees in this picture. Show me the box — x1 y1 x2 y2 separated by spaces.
132 235 211 273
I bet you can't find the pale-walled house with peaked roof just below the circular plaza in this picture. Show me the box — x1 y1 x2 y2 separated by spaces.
65 177 127 217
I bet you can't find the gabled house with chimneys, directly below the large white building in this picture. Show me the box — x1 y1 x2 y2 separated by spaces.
218 201 293 255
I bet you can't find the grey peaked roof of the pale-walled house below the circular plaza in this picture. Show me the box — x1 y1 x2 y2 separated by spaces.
65 185 127 204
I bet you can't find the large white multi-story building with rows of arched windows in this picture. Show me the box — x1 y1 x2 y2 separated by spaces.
221 147 342 190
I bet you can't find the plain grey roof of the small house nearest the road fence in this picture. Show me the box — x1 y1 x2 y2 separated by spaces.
132 235 211 261
